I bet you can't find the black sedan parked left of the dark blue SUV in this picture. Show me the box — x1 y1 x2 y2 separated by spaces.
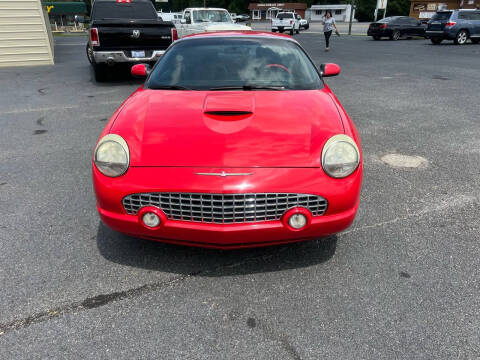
367 16 425 40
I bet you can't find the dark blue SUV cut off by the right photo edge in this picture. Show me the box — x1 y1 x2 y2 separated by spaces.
425 9 480 45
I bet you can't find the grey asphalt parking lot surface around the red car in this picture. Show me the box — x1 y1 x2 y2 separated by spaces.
0 32 480 359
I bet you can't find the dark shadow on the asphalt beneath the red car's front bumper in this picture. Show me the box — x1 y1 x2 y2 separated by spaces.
97 222 337 277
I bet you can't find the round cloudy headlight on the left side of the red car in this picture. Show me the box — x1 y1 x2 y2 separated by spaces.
94 134 130 177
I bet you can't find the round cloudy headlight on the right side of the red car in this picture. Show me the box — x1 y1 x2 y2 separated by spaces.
322 135 360 178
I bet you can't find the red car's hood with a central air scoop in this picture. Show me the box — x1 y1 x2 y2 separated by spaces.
110 89 344 167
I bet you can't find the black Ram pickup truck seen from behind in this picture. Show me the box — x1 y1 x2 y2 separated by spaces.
87 0 177 81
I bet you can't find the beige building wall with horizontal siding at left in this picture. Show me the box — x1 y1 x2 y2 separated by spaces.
0 0 53 67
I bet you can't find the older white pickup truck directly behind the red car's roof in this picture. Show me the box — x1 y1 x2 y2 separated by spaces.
176 8 252 37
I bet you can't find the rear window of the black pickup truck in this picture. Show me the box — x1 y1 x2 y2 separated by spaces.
92 2 158 20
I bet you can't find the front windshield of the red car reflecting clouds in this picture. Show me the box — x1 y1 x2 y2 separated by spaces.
147 37 323 90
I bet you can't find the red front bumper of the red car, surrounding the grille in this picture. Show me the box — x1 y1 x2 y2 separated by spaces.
93 166 362 249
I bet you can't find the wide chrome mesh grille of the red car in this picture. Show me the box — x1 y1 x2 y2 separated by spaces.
123 193 327 224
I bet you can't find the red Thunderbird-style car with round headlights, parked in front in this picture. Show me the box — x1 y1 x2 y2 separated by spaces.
93 31 362 249
